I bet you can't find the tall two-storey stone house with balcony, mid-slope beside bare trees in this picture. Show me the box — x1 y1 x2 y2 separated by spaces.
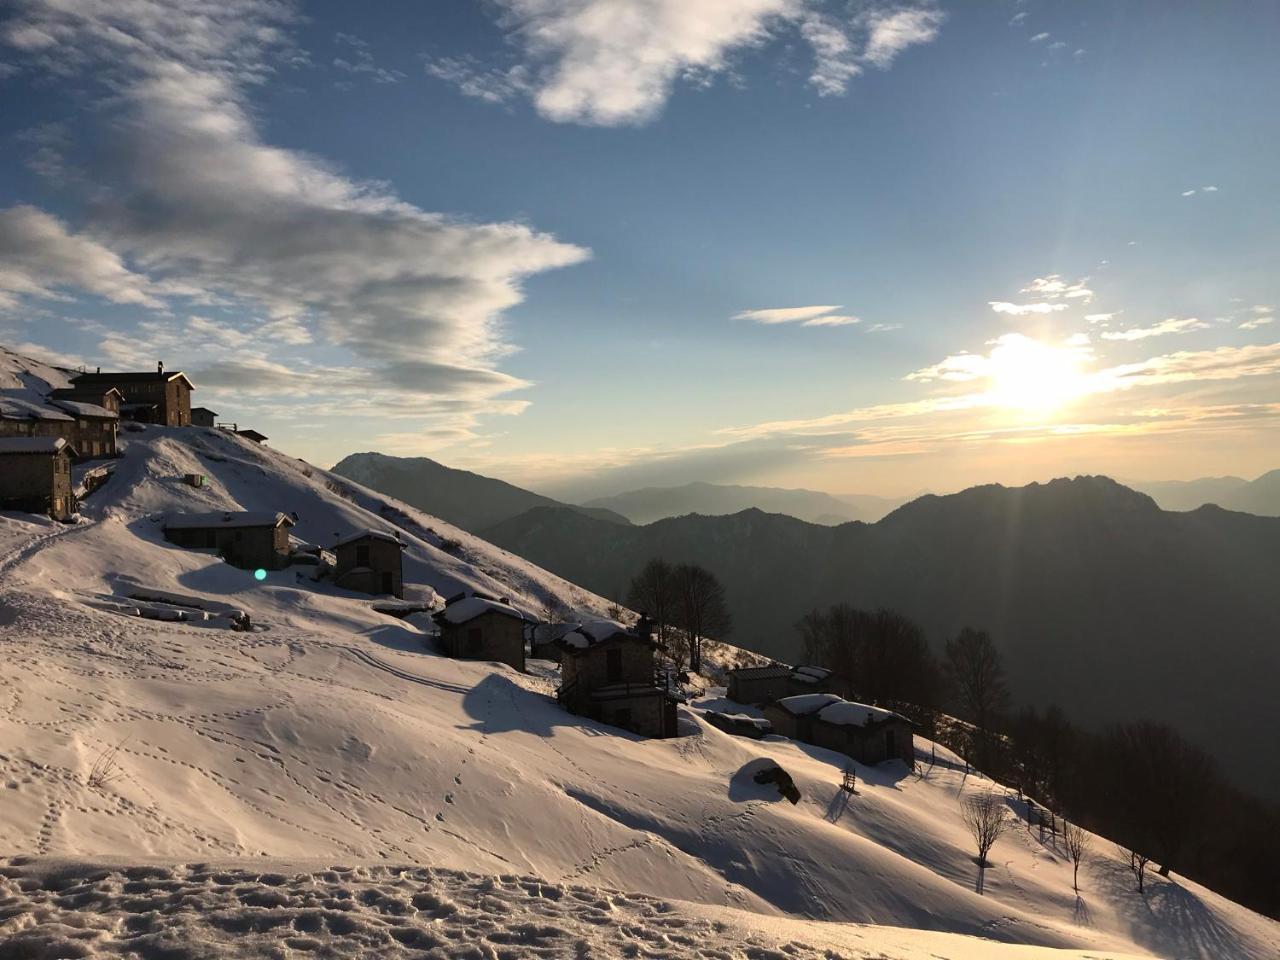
557 618 676 737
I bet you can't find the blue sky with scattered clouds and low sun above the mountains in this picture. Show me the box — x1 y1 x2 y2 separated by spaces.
0 0 1280 499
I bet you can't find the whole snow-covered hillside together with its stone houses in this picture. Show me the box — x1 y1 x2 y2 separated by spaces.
0 353 1280 960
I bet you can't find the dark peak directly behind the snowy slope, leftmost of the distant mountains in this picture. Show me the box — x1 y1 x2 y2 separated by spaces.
333 453 630 532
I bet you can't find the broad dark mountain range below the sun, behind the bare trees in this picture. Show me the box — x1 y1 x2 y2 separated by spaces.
480 476 1280 796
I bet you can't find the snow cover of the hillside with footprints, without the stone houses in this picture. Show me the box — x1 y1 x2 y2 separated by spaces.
0 348 1280 960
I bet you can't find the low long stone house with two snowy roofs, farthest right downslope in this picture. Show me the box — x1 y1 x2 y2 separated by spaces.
764 694 915 764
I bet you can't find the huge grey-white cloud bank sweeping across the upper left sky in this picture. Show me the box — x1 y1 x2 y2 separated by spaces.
0 0 589 435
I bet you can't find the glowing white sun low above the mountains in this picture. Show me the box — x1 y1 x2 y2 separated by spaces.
987 334 1089 415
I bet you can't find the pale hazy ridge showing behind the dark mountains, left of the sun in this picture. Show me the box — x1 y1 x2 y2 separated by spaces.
585 483 908 526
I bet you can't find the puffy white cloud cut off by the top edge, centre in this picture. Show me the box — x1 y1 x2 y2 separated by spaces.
426 0 942 127
